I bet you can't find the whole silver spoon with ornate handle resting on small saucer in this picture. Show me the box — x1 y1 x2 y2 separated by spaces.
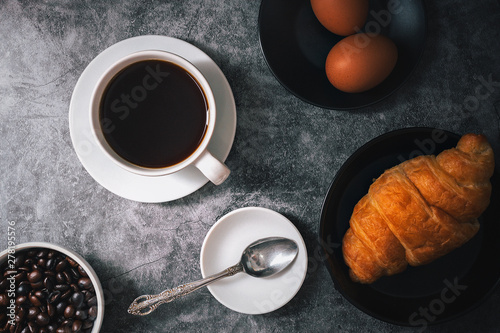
128 237 299 316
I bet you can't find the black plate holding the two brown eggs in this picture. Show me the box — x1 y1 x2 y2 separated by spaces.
259 0 426 109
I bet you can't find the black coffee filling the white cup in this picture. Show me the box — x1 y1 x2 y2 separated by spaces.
99 60 208 168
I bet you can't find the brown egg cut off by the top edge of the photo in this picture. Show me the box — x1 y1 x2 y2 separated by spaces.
311 0 369 36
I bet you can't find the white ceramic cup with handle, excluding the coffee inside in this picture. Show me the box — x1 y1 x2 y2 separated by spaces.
89 50 230 185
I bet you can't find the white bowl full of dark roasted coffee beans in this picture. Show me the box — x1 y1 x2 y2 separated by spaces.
0 242 104 333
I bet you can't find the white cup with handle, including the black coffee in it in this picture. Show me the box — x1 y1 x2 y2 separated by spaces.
90 50 230 185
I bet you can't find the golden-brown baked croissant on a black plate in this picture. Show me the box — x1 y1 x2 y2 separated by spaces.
342 134 495 283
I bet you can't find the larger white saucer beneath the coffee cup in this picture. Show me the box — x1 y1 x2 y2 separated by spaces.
69 36 236 202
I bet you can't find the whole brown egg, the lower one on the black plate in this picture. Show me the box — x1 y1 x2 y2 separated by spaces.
325 33 398 93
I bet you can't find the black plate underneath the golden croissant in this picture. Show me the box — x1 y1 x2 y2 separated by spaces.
320 128 500 327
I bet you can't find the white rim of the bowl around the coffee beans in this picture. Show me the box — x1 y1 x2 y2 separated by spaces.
0 242 104 333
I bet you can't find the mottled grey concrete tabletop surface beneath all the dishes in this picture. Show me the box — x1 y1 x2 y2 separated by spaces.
0 0 500 332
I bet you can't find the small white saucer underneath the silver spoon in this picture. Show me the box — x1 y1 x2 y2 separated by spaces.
200 207 307 314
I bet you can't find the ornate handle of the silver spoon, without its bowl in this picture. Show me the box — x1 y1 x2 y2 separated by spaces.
128 263 243 316
